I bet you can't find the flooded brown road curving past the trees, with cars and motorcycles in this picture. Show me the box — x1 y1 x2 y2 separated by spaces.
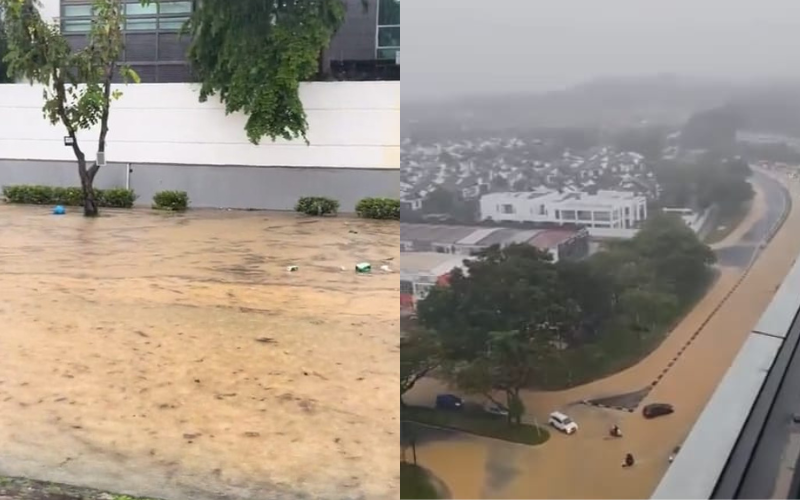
411 170 800 498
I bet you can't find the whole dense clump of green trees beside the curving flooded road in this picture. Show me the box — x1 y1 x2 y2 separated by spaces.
416 215 715 410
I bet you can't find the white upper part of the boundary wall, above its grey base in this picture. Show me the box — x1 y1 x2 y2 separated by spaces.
0 82 400 170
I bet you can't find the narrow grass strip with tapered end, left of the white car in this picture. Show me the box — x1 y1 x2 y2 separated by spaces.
400 406 550 445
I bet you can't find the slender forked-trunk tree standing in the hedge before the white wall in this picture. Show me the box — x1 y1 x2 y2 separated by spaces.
0 0 139 216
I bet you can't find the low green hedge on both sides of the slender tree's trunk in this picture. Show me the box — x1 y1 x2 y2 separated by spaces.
3 184 136 208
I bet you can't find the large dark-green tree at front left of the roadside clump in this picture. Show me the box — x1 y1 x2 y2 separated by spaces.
417 244 579 416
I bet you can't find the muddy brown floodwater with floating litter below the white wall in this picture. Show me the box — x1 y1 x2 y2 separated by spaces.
0 206 399 500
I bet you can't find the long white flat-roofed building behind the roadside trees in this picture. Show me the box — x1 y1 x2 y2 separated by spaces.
480 190 647 229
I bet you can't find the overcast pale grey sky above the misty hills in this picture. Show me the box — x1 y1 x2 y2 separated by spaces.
401 0 800 100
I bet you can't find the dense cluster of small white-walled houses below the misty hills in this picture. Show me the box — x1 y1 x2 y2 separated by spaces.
400 139 659 210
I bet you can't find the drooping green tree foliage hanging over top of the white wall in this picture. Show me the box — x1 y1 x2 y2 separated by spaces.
187 0 345 144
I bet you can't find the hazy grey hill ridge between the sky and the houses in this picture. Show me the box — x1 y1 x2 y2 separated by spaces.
402 75 800 143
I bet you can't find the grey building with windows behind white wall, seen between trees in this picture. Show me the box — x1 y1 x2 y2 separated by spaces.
50 0 400 83
